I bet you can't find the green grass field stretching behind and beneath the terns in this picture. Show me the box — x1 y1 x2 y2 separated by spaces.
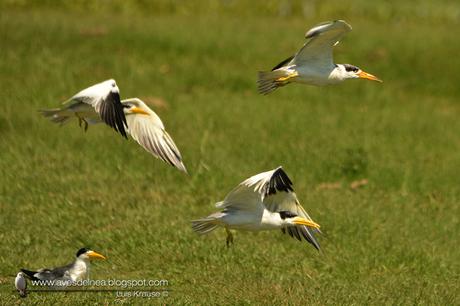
0 1 460 305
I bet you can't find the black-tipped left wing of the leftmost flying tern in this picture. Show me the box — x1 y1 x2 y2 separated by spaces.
64 80 127 137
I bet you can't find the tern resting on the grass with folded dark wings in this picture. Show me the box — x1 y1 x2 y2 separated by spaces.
21 248 106 285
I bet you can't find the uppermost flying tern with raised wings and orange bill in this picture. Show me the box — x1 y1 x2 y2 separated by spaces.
258 20 382 94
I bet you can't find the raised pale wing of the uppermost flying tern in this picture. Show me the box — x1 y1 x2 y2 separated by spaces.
290 20 351 68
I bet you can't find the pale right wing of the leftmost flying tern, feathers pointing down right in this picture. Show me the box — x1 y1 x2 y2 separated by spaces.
122 98 187 173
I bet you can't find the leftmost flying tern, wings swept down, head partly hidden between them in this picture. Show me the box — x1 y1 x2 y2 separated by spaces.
41 80 187 173
